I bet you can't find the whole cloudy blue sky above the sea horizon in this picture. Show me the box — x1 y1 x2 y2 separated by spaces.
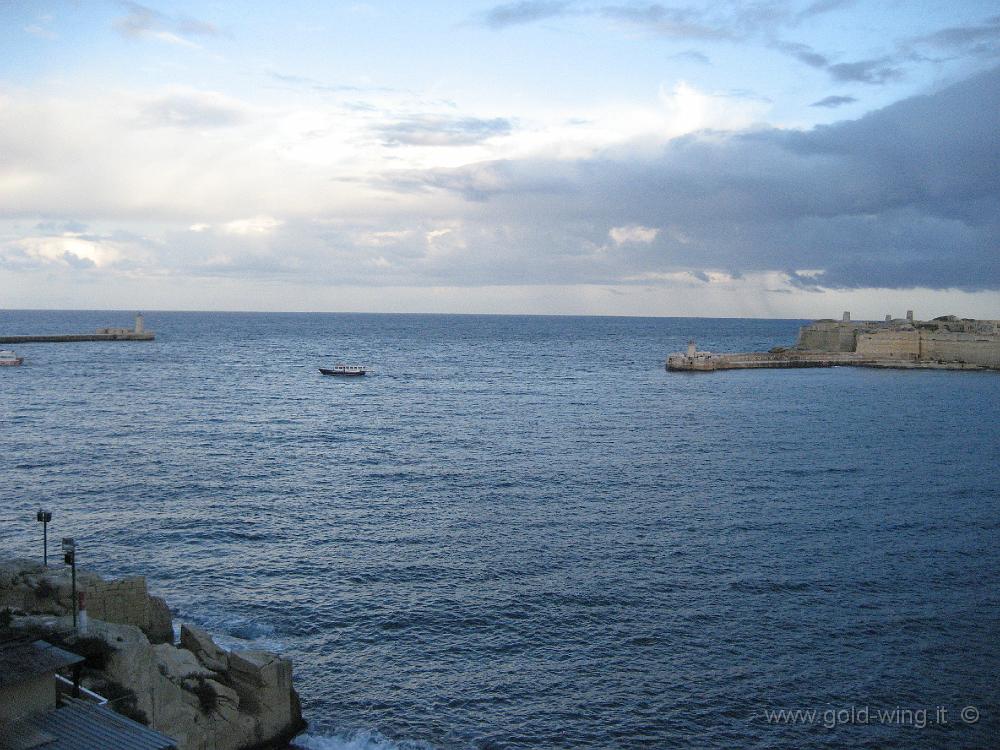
0 0 1000 319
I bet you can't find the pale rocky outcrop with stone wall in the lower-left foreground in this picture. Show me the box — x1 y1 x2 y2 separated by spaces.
0 560 305 750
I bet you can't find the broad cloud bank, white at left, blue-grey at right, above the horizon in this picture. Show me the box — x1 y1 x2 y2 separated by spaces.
0 62 1000 296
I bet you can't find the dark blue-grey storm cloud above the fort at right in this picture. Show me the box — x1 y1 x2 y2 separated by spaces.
380 68 1000 290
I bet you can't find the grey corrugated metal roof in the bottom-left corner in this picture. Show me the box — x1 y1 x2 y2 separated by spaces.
24 698 177 750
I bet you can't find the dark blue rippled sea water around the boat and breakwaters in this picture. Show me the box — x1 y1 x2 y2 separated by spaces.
0 312 1000 748
